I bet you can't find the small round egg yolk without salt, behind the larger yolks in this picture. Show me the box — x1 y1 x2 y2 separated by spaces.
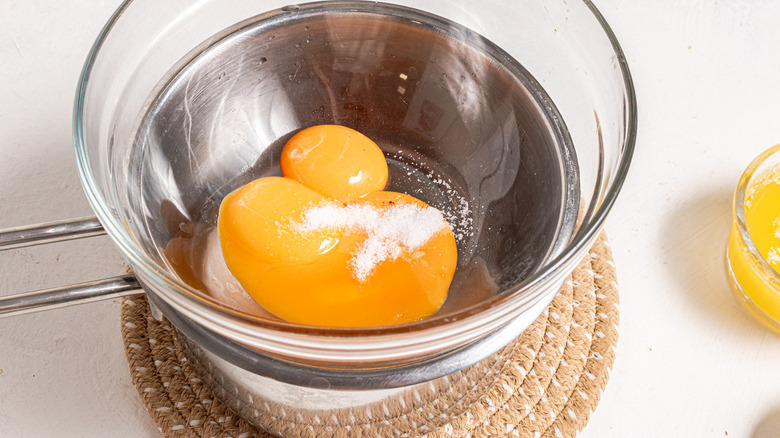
279 125 387 201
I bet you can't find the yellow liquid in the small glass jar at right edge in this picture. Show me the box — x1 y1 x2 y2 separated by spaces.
728 166 780 330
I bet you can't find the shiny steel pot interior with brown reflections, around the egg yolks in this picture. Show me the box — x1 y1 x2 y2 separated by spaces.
125 3 580 318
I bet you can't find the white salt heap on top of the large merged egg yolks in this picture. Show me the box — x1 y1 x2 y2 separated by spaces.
299 203 447 282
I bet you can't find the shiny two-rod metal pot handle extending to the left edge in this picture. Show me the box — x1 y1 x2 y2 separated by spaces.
0 217 143 318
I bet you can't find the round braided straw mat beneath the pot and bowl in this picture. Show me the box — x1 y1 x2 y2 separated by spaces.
122 234 618 438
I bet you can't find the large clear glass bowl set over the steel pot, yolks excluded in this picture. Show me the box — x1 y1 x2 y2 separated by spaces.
74 0 636 386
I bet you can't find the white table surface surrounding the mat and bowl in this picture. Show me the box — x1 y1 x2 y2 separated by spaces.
0 0 780 438
